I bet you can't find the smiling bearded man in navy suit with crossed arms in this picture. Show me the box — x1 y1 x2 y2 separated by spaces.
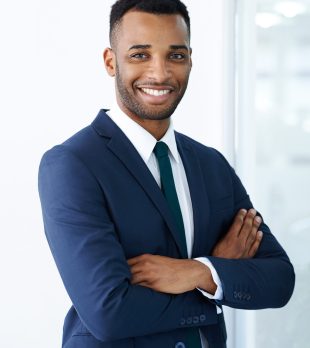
39 0 294 348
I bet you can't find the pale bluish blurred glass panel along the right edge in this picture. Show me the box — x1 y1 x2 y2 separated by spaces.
255 0 310 348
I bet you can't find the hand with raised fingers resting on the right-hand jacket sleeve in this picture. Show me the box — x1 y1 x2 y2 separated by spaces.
212 209 263 259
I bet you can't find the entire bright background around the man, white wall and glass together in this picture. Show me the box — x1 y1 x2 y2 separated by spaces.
0 0 310 348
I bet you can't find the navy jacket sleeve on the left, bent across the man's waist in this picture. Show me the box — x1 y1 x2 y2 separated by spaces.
39 146 217 341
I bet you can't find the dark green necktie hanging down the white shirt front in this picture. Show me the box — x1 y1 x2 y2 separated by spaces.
154 141 201 348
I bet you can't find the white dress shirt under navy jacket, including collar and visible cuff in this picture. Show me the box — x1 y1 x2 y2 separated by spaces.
107 103 223 348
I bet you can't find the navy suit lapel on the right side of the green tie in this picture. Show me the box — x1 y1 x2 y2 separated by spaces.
176 132 210 257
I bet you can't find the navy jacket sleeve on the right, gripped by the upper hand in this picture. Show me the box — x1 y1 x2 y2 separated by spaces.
208 151 295 309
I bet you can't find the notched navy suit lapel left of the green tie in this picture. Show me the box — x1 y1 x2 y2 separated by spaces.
92 110 186 258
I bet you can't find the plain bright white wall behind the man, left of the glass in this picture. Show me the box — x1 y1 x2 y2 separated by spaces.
0 0 228 348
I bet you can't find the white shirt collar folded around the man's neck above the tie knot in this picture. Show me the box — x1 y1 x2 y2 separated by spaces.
107 102 180 163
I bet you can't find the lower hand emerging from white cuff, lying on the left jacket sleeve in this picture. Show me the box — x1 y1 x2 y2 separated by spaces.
127 254 216 294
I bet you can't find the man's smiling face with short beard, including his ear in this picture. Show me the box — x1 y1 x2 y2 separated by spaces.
104 11 191 132
